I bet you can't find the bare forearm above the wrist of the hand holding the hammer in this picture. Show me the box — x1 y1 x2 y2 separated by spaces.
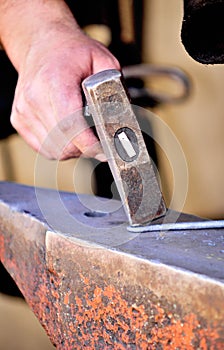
0 0 78 70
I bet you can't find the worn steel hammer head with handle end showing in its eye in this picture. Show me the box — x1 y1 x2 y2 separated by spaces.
82 69 166 226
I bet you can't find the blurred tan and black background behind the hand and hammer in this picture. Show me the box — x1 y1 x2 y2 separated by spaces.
0 0 224 350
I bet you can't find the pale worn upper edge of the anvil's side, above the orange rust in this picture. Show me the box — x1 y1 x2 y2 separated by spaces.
46 230 224 321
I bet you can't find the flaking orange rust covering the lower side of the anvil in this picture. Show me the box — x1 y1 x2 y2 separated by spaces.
3 231 220 350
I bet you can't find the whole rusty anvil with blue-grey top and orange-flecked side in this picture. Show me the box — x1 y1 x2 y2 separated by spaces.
0 182 224 349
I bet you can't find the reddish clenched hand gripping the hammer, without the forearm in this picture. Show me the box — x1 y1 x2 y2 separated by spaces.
0 0 119 160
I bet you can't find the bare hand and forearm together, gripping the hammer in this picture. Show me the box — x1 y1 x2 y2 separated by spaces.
0 0 120 161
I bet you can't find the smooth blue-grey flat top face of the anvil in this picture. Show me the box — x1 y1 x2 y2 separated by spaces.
0 182 224 280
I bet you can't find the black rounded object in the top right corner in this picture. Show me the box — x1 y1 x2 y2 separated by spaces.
181 0 224 64
